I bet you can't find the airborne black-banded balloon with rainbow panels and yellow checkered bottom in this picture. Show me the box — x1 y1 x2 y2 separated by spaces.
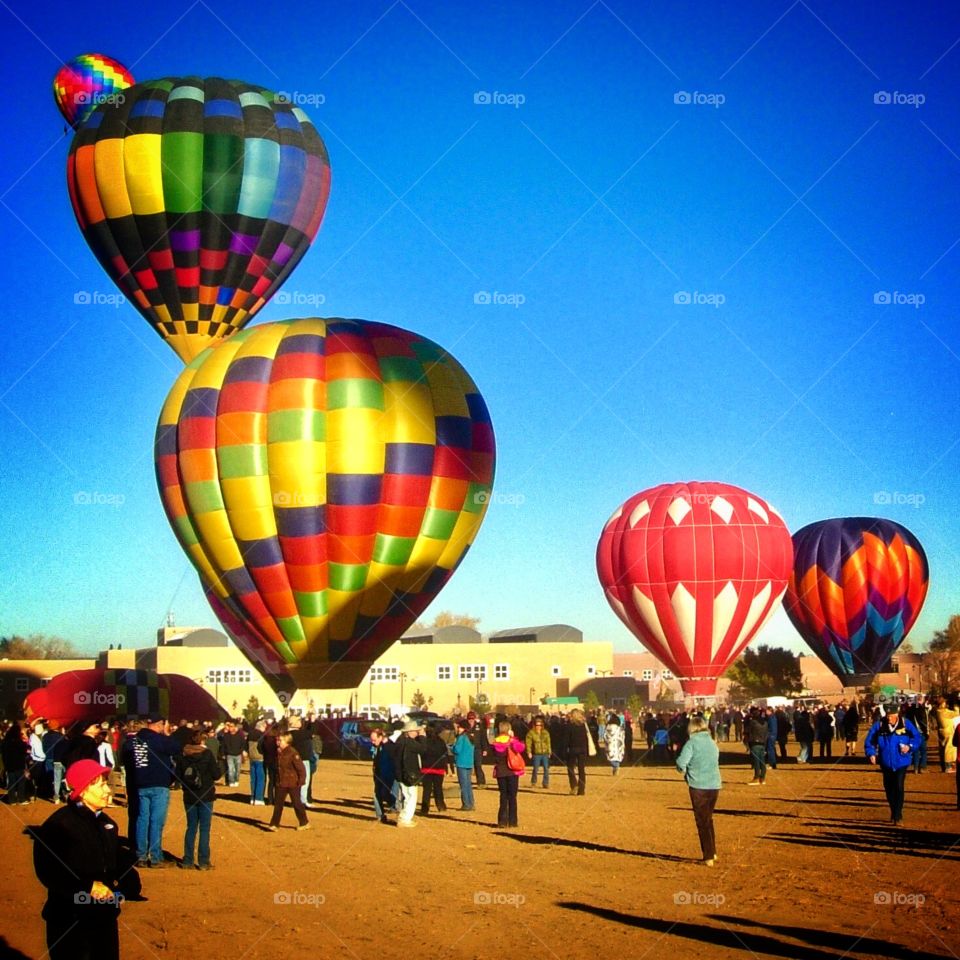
67 77 330 363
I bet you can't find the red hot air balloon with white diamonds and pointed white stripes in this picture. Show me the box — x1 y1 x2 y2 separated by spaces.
597 482 793 696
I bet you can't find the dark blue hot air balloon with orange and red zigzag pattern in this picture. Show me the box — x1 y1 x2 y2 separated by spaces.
784 517 929 686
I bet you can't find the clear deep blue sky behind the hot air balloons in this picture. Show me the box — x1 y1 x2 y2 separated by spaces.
0 0 960 650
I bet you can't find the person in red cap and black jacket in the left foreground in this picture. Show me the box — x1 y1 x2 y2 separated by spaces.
32 760 140 960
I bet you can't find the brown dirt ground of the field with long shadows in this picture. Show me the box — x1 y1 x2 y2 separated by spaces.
0 744 960 960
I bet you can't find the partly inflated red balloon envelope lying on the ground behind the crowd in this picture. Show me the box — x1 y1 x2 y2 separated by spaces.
24 668 227 726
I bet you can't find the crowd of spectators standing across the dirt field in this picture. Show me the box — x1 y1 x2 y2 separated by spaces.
0 698 960 960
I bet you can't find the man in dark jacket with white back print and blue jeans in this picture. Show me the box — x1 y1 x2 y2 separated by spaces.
121 714 183 867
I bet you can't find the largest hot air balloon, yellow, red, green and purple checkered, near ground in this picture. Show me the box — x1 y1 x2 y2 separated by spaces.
155 319 494 693
